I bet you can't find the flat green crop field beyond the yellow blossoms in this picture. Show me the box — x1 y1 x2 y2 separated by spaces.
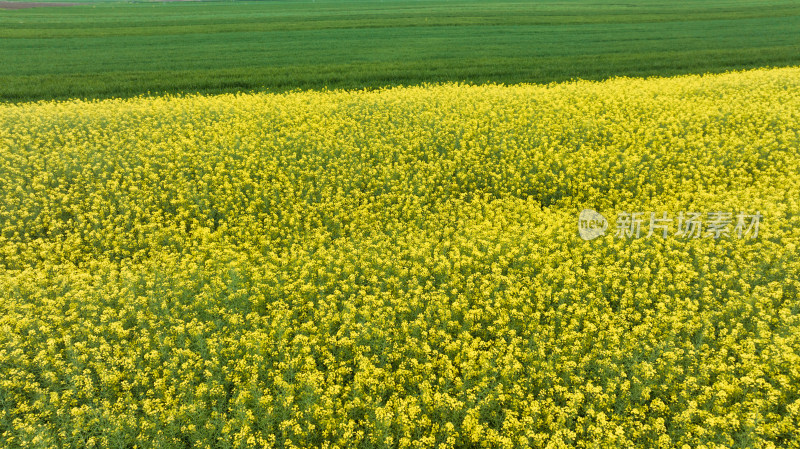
0 0 800 101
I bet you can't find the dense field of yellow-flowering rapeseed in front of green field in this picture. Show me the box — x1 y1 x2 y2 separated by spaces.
0 68 800 448
